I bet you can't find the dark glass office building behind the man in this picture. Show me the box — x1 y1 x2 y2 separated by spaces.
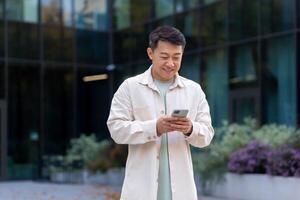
0 0 300 179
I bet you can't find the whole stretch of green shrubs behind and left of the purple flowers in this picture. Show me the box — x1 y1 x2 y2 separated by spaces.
193 118 300 187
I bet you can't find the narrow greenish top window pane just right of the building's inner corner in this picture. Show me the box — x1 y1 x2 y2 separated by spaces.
114 0 130 30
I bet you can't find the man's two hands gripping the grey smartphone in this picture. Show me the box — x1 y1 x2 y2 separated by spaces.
156 116 193 136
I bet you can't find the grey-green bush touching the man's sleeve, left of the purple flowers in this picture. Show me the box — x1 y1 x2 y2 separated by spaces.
193 118 256 184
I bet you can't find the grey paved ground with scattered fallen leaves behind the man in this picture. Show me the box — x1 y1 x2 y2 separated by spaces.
0 181 225 200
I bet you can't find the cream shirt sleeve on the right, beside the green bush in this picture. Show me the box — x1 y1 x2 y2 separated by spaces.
186 88 214 147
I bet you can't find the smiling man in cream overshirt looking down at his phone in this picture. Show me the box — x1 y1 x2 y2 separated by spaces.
107 26 214 200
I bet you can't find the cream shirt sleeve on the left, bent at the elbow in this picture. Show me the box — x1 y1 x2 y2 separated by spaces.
107 81 157 144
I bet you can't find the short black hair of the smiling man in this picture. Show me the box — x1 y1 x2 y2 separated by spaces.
149 26 186 49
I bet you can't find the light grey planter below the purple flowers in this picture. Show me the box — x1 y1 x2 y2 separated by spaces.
202 173 300 200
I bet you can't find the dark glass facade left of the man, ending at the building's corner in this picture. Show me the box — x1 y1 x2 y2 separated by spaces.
0 0 112 180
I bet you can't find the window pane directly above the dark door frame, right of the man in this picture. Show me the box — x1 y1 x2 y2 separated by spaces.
230 44 258 84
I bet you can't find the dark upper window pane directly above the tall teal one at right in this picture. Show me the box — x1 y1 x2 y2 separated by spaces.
261 0 295 33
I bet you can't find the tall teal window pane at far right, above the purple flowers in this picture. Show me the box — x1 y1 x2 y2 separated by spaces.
262 36 297 126
